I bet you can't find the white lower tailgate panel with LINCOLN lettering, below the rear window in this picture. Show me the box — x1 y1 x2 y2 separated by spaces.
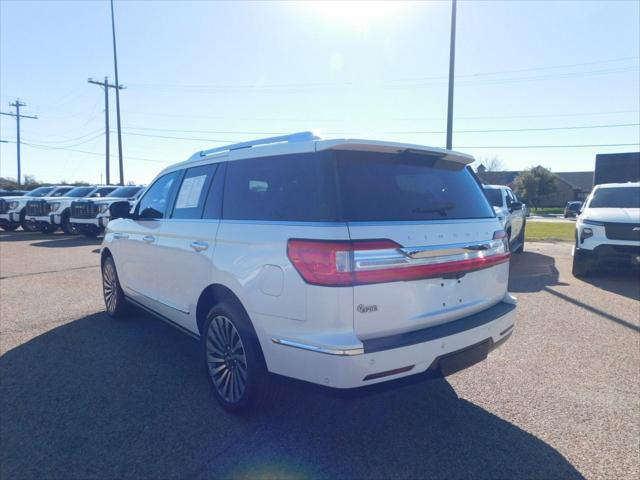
349 218 509 340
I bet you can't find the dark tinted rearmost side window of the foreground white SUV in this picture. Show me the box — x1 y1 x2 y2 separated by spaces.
223 152 337 222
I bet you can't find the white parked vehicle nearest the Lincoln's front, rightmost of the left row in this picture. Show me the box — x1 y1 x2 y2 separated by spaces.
70 186 144 237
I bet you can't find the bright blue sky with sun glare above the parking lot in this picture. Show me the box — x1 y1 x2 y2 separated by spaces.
0 0 640 183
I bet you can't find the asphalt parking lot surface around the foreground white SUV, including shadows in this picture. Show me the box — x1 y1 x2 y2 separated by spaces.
0 232 640 479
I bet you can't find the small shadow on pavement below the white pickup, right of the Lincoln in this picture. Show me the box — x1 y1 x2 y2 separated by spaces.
509 251 566 293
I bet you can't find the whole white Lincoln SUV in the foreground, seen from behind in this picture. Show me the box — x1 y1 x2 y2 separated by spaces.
101 132 515 411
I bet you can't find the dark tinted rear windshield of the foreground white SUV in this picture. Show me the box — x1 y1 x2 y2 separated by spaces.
336 151 494 222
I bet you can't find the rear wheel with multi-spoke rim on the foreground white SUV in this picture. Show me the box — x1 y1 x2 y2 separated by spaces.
201 301 273 413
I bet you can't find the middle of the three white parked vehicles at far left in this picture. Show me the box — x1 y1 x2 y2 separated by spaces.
26 185 118 235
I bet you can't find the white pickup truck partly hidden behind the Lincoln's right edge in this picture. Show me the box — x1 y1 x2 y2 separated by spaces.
483 185 527 253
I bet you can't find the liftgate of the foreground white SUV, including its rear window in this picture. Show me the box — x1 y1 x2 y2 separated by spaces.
336 151 509 339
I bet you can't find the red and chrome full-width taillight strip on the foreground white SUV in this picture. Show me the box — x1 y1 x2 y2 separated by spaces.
287 231 510 287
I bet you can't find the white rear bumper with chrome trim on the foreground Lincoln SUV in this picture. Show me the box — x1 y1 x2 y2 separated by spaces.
261 301 516 389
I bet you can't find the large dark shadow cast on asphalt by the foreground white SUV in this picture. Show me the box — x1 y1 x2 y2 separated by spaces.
0 313 582 479
